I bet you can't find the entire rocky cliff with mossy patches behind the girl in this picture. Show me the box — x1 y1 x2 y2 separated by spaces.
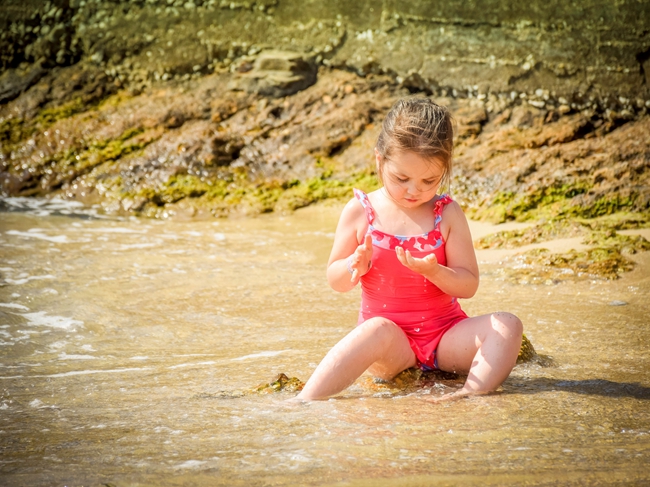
0 0 650 225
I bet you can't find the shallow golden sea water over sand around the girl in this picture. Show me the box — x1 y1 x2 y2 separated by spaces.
0 199 650 486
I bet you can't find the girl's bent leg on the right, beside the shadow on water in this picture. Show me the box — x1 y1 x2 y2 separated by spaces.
437 313 523 396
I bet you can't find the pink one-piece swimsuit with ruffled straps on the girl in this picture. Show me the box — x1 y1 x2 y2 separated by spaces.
354 189 467 370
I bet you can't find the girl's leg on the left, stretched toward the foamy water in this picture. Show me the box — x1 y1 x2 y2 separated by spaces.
297 318 415 401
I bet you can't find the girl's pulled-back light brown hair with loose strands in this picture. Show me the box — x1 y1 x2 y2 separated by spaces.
376 97 454 187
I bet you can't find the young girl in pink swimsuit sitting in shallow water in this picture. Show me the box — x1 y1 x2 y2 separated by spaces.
298 98 522 400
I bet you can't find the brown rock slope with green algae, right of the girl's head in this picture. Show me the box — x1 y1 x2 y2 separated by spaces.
454 111 650 223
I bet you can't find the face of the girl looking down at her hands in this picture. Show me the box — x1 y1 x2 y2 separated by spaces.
375 149 444 208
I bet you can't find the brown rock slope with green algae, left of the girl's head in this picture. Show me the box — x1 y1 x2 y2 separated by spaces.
0 65 396 217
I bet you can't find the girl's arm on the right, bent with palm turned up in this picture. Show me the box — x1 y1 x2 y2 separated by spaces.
397 201 479 298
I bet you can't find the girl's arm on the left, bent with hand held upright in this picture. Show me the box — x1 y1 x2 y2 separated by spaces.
327 198 372 292
